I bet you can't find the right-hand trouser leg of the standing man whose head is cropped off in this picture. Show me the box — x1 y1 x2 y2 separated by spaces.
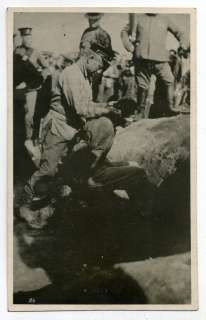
154 62 174 115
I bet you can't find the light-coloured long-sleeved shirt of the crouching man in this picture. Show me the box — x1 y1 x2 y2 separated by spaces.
50 61 108 134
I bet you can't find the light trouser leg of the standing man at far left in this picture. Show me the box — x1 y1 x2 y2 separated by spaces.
24 91 37 139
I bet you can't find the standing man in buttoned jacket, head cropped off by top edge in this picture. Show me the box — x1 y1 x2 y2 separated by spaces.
121 13 189 117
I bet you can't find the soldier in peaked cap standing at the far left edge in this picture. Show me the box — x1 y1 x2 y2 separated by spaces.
14 27 48 150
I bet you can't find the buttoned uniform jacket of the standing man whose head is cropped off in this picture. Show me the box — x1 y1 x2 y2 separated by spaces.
121 14 187 62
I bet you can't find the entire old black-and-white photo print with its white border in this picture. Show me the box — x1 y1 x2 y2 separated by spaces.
8 8 197 311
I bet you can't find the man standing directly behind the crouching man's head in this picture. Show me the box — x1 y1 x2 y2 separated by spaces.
80 12 112 101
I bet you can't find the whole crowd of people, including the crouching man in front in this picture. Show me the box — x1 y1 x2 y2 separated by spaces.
13 12 190 227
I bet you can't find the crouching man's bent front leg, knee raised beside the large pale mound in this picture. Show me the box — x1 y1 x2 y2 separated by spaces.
82 117 151 193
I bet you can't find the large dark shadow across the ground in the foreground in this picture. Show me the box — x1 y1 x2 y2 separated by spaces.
14 162 190 304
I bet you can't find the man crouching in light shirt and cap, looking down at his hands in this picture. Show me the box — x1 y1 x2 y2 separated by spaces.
20 45 154 228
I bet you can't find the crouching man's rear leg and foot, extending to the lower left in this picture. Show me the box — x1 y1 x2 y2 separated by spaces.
19 131 68 228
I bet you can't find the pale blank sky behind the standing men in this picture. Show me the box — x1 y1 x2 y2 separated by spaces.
14 12 189 53
